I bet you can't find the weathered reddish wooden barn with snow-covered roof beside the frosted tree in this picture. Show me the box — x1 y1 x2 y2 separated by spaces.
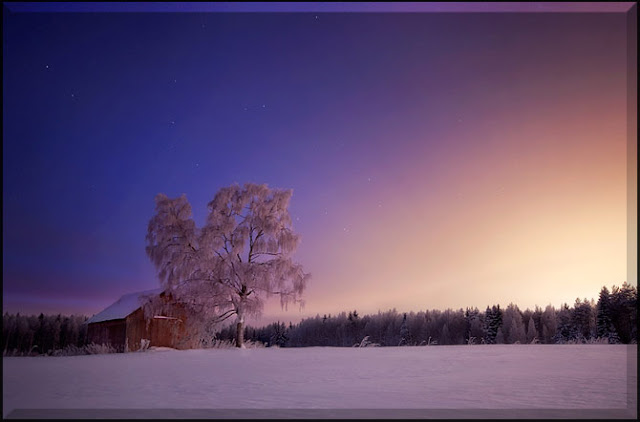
87 289 189 352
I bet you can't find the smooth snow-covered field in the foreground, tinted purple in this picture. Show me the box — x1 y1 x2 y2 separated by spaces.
2 345 637 419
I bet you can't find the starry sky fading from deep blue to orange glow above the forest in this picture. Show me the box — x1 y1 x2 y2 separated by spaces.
3 3 635 322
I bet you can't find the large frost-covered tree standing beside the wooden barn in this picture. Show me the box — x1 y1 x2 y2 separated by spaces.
146 183 310 347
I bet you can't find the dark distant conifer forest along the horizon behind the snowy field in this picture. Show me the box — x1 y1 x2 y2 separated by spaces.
2 282 638 356
